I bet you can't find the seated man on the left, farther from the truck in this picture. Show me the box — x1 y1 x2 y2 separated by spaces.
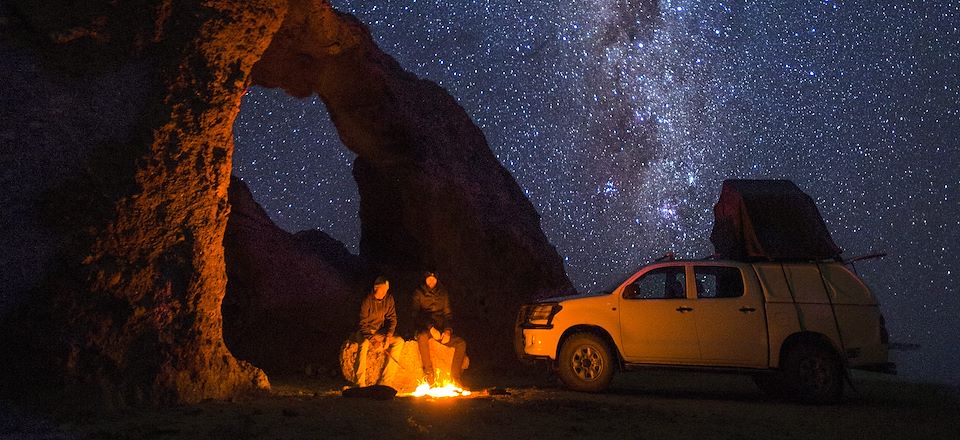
357 277 403 387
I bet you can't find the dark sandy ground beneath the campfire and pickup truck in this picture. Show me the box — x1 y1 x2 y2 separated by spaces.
0 372 960 440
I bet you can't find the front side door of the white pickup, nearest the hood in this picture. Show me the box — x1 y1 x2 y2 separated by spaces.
620 264 700 364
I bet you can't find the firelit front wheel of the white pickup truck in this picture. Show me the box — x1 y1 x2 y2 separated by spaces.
557 333 615 393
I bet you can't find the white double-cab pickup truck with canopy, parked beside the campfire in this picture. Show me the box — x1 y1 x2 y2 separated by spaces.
514 259 895 403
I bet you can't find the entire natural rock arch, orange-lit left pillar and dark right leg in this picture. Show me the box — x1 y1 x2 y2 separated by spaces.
0 0 569 407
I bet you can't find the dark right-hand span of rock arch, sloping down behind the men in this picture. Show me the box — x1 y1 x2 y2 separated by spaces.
251 2 570 372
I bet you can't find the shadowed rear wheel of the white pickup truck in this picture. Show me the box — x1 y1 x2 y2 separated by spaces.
783 344 843 404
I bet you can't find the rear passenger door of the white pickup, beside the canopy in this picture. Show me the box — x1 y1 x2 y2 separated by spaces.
692 264 767 367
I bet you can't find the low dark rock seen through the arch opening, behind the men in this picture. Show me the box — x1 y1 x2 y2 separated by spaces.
223 178 369 374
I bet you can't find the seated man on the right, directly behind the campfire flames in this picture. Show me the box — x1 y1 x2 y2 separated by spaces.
413 272 467 385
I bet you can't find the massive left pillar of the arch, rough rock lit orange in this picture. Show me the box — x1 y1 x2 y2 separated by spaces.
0 0 286 408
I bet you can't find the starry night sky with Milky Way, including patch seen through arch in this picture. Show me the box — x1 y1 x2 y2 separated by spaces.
234 0 960 384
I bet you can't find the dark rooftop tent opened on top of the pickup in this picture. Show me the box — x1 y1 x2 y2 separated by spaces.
710 179 843 260
